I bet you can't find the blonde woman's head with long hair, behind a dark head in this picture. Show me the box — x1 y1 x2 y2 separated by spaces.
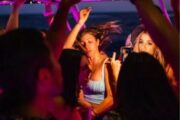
134 30 165 67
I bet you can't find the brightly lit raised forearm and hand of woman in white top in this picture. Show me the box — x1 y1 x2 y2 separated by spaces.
63 7 91 48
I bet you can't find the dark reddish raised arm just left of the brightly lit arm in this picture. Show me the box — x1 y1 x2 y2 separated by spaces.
46 0 80 59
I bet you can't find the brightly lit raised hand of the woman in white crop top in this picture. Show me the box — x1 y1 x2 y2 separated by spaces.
78 7 91 25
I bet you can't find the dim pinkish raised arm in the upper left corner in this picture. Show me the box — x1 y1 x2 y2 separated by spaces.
5 0 25 32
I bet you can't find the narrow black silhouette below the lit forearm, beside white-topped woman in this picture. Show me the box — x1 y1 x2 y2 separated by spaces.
59 49 83 107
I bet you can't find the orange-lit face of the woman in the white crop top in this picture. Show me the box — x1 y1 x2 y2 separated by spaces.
80 33 99 56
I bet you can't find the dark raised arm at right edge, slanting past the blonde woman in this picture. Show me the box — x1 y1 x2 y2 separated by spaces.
131 0 179 78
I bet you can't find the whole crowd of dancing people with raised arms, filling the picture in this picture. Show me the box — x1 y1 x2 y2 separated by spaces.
0 0 179 120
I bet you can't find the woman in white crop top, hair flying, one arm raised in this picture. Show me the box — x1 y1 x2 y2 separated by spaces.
64 8 120 117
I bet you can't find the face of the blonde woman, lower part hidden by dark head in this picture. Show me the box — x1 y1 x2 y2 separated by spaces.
137 32 156 55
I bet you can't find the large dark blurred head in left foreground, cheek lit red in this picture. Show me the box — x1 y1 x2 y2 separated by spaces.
0 29 61 114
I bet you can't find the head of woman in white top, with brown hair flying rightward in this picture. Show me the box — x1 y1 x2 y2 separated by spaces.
78 21 121 56
